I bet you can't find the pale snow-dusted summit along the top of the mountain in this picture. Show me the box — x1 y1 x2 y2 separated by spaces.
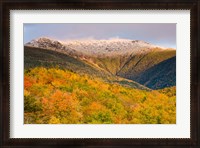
25 37 170 56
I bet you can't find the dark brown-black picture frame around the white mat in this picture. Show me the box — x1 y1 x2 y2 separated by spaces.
0 0 200 148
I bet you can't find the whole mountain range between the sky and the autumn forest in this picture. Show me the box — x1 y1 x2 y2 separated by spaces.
25 37 176 89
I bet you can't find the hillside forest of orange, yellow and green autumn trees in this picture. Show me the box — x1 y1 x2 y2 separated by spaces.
24 67 176 124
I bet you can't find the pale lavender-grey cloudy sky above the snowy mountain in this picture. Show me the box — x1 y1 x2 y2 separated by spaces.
24 23 176 48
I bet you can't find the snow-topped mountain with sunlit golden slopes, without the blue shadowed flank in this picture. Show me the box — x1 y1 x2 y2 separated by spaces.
25 37 176 89
